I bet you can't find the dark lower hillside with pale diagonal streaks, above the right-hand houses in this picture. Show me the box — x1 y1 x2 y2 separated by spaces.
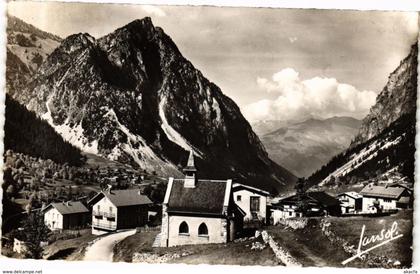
308 113 416 185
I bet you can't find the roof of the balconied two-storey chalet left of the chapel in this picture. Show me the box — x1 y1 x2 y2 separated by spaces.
91 189 153 207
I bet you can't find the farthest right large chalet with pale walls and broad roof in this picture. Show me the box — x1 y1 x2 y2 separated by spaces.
359 184 412 213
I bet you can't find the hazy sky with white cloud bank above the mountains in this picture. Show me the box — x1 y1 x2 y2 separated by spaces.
8 1 418 122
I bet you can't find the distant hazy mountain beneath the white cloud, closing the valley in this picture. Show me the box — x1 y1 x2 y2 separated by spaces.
261 117 361 177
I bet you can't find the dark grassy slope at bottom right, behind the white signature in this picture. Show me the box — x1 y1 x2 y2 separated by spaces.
267 211 413 267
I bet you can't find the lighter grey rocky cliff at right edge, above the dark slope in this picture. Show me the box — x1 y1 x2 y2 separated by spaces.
352 43 418 147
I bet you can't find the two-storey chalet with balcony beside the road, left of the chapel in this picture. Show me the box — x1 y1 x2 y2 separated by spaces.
88 187 152 235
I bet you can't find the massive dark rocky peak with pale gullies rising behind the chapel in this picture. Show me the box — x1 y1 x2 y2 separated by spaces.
20 18 296 192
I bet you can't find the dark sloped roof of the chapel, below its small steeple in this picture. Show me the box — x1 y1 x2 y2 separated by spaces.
167 179 230 214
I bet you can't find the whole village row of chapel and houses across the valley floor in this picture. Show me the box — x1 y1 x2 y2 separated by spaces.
9 152 413 255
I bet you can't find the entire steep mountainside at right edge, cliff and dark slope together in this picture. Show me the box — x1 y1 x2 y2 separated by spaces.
309 44 418 185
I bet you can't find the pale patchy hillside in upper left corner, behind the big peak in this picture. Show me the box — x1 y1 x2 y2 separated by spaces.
6 15 61 99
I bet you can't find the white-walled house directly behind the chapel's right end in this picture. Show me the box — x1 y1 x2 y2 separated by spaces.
232 183 270 222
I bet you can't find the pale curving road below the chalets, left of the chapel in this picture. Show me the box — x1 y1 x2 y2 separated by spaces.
83 229 136 262
